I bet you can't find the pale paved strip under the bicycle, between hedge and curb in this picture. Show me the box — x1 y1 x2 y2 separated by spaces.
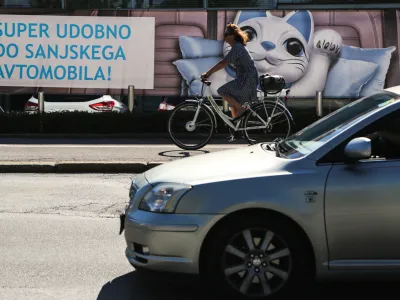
0 138 247 162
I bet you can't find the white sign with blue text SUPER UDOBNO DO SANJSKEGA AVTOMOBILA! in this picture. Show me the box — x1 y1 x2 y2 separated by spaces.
0 15 155 89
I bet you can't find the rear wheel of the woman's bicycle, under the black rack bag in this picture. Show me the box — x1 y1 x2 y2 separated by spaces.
243 102 291 144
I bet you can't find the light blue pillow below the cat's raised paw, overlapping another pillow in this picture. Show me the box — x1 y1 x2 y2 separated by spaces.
323 58 378 98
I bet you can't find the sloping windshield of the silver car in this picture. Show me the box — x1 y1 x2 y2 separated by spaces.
278 92 400 159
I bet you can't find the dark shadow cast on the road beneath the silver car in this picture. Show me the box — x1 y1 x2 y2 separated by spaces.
97 271 400 300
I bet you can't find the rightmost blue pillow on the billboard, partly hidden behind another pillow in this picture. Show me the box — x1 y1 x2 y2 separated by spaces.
339 46 396 97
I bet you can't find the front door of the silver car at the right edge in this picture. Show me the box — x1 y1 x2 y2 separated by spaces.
325 111 400 269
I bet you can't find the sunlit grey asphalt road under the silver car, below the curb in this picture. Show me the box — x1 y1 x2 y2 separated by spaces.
0 174 400 300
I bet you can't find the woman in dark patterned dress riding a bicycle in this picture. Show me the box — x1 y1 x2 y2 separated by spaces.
201 24 258 119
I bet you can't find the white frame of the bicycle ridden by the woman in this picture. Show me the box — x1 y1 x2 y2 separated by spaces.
187 78 292 131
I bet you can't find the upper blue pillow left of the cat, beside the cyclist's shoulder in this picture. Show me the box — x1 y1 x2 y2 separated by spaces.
179 36 224 58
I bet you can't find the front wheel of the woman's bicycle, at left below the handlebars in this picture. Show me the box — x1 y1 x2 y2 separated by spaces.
168 103 214 150
